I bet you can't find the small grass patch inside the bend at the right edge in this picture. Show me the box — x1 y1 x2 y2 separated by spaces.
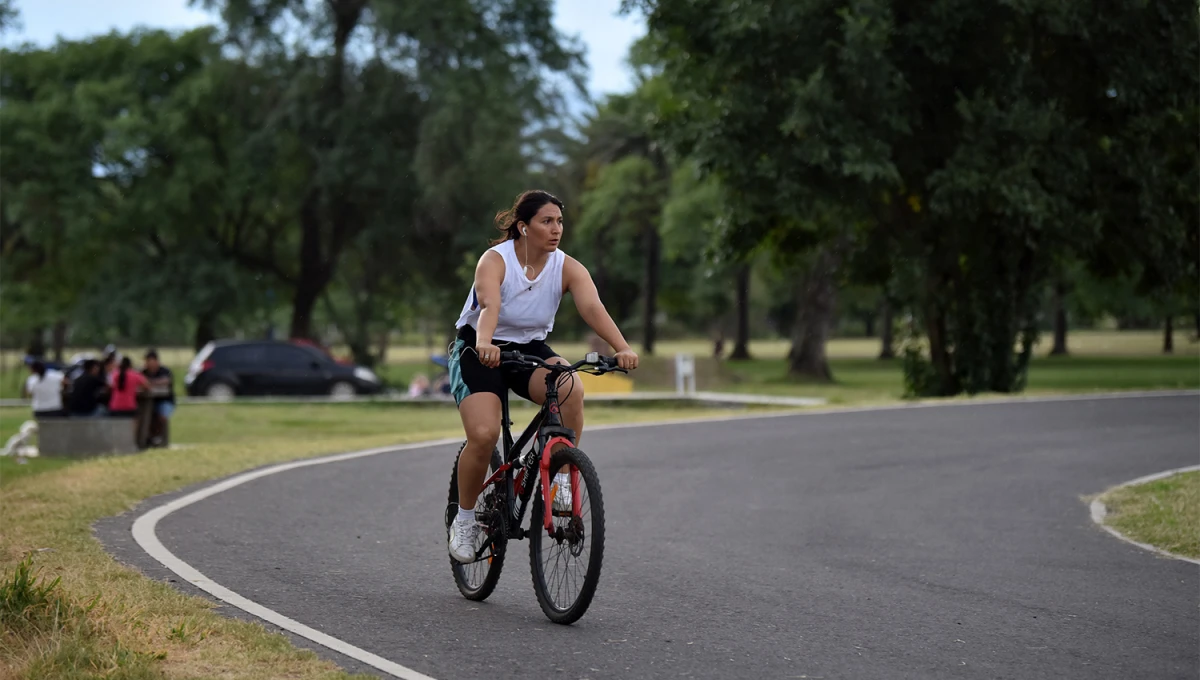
1099 471 1200 559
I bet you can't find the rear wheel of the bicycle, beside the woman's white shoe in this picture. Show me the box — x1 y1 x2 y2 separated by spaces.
443 443 508 601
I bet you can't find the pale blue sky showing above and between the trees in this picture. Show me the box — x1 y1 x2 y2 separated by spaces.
4 0 644 97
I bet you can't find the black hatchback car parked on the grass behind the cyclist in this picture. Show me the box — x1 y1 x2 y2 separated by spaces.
184 339 383 399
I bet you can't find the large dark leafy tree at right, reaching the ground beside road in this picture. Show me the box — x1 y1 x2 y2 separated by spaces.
625 0 1196 395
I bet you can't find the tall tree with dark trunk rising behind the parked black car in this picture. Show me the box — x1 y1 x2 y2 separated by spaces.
192 0 580 337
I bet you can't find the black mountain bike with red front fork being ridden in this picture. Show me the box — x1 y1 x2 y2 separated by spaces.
445 351 626 625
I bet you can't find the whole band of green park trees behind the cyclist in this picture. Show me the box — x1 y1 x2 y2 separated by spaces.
0 0 1200 395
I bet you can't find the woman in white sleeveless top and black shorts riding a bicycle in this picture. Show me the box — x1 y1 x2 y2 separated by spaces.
449 191 637 562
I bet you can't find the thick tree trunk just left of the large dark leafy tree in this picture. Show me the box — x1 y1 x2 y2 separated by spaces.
787 248 838 383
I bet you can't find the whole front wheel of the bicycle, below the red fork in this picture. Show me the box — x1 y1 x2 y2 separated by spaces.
529 449 604 625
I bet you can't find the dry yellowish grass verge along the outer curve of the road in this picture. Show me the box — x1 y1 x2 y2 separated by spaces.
0 404 777 680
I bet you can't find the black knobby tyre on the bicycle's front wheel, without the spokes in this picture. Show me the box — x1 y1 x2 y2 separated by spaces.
529 449 604 625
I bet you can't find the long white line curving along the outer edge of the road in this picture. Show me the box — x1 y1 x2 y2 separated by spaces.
126 391 1200 680
